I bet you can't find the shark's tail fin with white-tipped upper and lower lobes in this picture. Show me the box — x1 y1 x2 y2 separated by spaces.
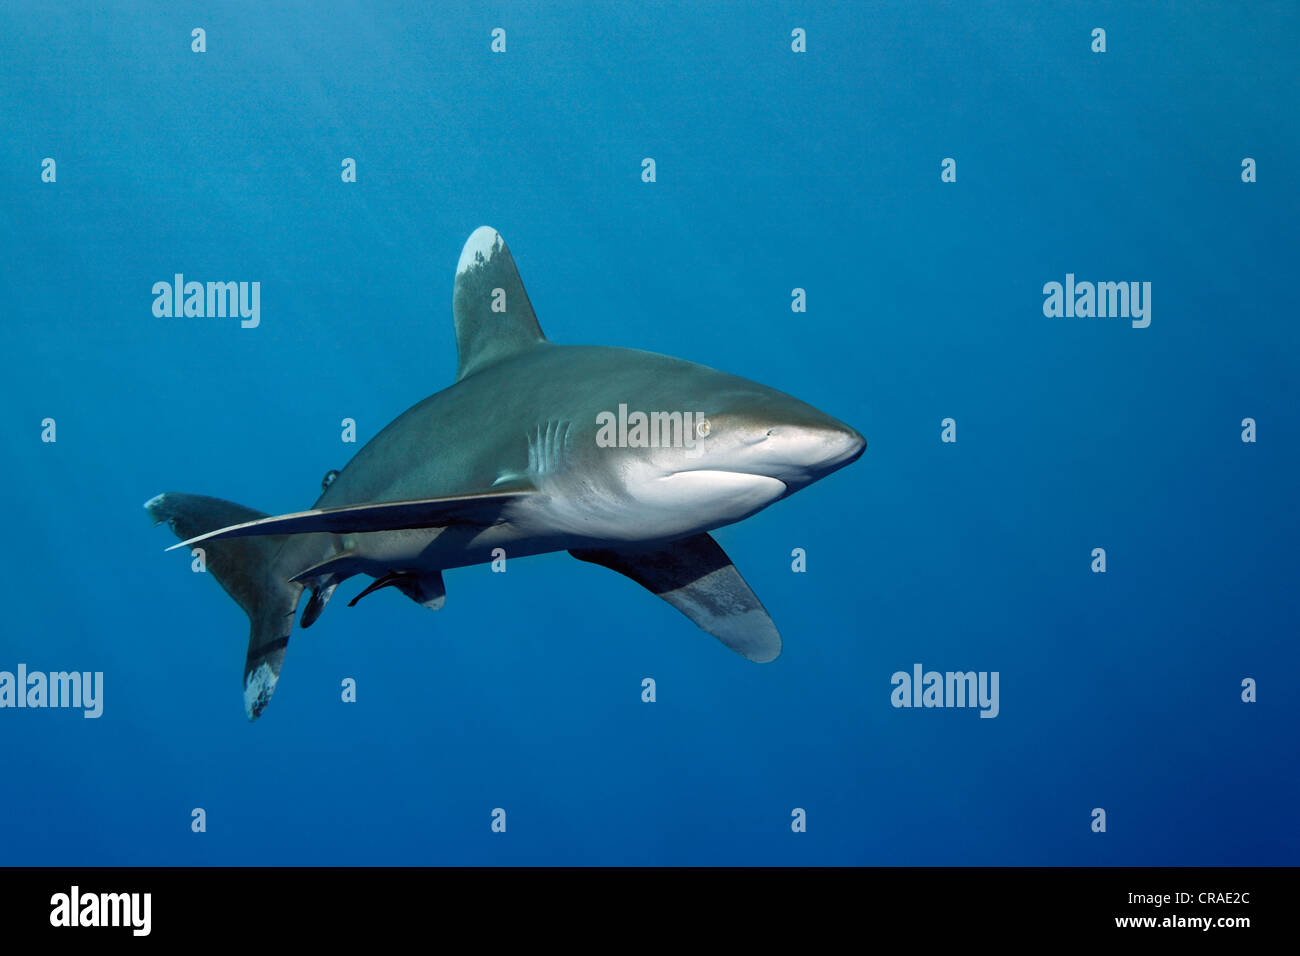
144 492 303 721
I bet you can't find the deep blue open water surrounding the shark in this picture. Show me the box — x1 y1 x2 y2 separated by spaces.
0 3 1300 865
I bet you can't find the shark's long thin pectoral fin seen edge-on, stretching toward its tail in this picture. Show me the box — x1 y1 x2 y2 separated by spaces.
168 489 532 551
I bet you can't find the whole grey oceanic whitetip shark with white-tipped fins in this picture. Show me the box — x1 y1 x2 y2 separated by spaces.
144 226 866 719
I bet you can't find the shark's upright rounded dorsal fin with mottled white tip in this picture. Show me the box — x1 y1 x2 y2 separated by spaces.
451 226 546 381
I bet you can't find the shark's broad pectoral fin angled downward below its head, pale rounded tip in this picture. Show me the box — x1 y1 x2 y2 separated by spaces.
569 535 781 663
